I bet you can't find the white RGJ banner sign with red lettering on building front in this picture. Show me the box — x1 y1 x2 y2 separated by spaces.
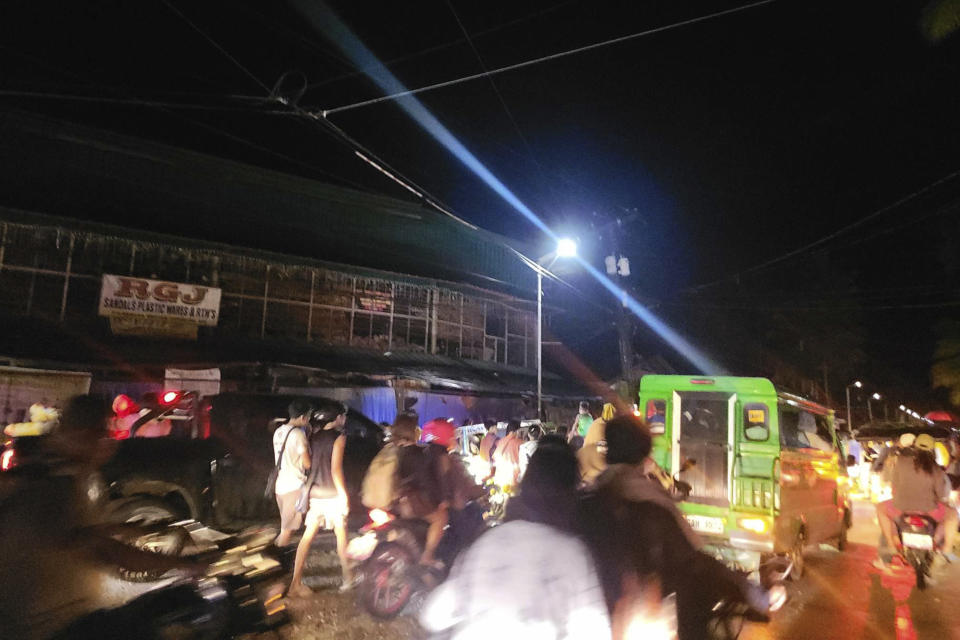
100 275 220 327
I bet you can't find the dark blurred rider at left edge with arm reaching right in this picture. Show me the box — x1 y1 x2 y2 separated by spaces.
0 396 206 640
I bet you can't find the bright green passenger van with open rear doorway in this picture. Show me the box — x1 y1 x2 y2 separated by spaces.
639 375 851 584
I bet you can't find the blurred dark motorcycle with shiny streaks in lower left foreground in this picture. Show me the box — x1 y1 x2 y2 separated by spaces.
54 522 289 640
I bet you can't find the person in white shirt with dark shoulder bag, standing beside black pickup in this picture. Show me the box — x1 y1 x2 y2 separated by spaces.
273 400 313 547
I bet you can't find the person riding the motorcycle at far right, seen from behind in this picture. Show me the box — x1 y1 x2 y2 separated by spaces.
877 433 957 562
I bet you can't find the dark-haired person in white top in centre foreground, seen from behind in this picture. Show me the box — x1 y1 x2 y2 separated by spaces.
420 436 611 640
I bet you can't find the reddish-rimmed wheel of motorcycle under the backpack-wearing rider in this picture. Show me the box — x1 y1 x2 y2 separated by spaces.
357 542 417 620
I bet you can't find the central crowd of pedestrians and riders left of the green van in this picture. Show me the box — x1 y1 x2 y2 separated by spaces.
274 403 784 640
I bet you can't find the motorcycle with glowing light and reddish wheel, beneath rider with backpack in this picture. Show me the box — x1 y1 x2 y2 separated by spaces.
347 503 486 620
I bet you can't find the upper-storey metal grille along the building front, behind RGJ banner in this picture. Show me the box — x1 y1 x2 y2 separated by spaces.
0 222 536 368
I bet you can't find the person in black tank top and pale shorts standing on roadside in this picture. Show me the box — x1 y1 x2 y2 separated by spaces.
288 402 353 597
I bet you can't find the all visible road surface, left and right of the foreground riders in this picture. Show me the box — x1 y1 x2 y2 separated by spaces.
258 502 960 640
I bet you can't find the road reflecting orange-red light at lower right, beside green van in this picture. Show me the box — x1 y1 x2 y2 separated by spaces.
740 503 960 640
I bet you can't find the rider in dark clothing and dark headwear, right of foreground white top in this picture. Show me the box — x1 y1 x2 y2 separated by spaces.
582 416 786 640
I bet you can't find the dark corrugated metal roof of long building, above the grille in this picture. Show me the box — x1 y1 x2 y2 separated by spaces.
0 111 536 298
